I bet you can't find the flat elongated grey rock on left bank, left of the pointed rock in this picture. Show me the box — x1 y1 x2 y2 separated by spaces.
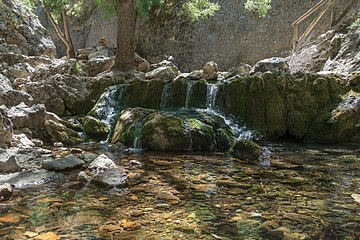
42 155 85 171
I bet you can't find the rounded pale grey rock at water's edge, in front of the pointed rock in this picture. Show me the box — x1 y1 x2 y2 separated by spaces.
93 168 127 188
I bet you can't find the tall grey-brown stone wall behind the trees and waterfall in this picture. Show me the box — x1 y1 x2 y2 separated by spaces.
38 0 356 71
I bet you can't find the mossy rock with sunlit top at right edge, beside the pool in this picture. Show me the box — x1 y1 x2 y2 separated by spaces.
305 91 360 143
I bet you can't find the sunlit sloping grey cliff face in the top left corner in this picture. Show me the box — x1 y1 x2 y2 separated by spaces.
0 0 55 57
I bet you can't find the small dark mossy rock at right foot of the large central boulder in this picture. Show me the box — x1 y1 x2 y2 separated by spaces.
231 140 261 161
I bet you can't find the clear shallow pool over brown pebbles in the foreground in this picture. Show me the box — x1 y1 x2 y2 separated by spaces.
0 143 360 240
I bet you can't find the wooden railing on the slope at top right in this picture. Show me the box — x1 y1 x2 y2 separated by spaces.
292 0 359 51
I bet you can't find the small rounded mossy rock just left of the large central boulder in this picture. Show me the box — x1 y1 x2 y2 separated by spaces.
83 116 110 140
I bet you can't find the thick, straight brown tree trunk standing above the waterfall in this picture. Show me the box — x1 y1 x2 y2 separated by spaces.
113 0 135 71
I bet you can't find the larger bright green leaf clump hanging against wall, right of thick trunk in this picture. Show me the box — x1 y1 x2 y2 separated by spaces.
183 0 220 21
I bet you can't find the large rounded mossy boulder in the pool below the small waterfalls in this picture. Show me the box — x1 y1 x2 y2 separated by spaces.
111 108 234 152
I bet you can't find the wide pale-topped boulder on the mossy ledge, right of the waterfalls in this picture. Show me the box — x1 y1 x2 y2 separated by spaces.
252 57 290 73
